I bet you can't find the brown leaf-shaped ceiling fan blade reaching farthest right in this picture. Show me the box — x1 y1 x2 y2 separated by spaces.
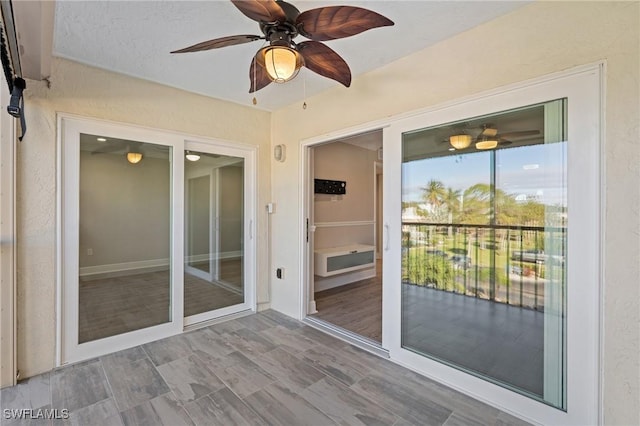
296 6 393 41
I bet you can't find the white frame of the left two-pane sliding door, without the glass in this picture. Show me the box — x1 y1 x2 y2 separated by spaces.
56 114 257 366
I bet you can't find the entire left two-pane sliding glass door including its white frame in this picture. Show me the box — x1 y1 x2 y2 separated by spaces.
58 117 255 364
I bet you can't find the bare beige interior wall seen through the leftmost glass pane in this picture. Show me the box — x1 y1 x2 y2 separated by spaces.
80 151 171 268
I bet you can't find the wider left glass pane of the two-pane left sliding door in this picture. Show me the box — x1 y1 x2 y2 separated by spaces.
78 134 171 343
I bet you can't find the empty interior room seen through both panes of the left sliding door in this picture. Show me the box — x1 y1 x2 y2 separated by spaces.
78 134 244 343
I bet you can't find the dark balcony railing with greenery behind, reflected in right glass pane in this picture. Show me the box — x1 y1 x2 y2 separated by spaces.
402 222 566 310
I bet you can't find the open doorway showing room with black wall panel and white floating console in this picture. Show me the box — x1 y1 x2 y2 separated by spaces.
309 130 383 346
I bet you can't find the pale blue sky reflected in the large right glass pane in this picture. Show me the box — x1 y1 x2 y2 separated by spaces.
402 142 566 205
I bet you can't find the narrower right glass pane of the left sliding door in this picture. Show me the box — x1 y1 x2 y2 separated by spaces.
184 151 244 316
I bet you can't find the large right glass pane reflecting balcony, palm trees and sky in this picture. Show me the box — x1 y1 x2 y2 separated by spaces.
402 100 567 409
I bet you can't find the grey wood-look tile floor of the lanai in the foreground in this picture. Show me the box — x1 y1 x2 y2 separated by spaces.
0 311 525 426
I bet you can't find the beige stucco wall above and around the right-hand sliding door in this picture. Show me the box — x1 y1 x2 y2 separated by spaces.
272 2 640 425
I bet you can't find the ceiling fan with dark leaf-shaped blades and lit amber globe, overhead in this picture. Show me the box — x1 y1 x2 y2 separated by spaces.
171 0 393 93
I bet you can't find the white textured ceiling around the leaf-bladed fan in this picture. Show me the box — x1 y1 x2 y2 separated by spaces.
53 0 527 110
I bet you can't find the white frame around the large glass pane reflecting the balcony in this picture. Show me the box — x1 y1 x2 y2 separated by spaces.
383 66 603 424
